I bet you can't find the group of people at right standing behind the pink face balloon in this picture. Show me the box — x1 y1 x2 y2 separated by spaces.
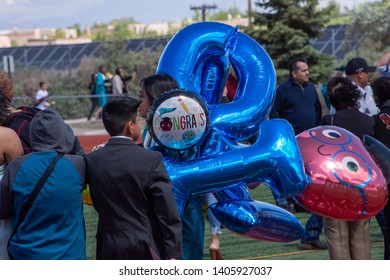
270 54 390 260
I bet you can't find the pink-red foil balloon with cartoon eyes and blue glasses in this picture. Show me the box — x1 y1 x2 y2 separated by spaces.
296 126 388 220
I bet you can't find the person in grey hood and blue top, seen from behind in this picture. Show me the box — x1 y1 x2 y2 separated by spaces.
0 108 86 260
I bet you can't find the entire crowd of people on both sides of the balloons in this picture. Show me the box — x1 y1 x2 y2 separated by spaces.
0 49 390 260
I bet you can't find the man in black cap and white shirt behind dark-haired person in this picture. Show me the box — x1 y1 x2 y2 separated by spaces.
345 57 378 116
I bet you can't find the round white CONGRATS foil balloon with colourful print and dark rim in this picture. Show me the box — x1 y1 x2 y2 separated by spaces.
147 90 208 150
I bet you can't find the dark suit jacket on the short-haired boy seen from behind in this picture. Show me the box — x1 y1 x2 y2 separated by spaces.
86 138 182 259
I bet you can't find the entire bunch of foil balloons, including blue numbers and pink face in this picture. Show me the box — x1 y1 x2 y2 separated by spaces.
147 22 387 242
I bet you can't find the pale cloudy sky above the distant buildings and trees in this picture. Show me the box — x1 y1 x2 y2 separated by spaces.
0 0 375 30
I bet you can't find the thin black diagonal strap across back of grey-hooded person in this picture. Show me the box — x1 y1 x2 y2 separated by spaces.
8 154 64 245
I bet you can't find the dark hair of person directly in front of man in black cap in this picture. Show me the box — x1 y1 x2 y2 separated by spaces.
327 76 362 111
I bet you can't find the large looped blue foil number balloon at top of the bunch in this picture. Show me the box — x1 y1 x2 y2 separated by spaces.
157 22 276 140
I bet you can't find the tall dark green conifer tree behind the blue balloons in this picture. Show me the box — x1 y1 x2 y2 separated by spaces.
244 0 336 83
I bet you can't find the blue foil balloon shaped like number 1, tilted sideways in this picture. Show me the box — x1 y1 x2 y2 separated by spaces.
165 119 309 211
